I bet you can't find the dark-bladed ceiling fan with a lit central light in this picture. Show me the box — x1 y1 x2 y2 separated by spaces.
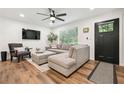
36 8 67 23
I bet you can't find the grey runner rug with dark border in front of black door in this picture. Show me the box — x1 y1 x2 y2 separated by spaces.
88 62 117 84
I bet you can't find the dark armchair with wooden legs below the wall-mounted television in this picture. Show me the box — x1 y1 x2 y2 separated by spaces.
8 43 31 62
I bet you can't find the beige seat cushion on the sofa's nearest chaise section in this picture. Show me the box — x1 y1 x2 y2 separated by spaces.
48 53 76 69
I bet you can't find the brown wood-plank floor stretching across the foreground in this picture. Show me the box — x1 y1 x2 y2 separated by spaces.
0 61 124 84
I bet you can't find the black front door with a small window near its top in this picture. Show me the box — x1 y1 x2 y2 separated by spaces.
95 18 119 64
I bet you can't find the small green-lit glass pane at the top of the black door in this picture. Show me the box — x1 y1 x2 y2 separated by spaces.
98 21 114 32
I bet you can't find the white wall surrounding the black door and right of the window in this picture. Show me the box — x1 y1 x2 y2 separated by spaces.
53 10 124 65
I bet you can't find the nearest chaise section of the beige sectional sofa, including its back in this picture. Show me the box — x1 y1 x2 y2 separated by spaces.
48 45 90 77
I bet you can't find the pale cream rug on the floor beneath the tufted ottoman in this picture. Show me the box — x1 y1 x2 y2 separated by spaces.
26 58 50 72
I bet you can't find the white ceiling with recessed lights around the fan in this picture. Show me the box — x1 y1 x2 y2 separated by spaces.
0 8 114 28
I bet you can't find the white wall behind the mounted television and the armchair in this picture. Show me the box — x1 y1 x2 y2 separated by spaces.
0 18 50 60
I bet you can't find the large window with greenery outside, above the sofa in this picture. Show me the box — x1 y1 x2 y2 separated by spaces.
59 27 78 44
